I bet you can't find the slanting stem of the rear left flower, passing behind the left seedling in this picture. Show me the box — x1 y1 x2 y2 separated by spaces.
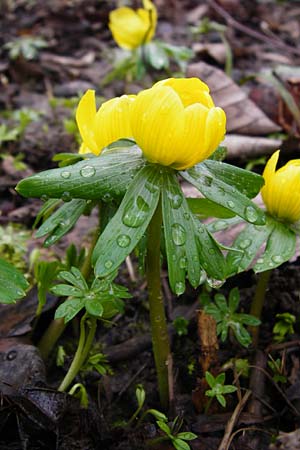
38 207 101 360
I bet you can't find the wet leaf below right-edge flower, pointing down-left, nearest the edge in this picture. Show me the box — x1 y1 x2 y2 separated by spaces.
253 219 296 273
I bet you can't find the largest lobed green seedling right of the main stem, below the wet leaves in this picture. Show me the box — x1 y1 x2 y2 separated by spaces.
201 288 260 347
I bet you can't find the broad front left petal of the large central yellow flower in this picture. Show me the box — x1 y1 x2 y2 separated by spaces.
130 86 184 165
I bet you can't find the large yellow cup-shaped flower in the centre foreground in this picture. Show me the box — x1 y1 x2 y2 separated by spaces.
130 78 226 170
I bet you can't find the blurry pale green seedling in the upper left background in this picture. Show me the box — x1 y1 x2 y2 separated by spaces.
3 36 48 61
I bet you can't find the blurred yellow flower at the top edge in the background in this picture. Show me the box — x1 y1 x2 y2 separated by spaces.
109 0 157 50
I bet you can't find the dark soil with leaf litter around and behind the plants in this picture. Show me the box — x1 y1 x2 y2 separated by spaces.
0 0 300 450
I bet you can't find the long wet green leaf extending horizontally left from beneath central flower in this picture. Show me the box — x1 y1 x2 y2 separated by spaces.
16 146 145 201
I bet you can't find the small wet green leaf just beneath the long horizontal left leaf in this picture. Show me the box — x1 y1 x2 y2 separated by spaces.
36 199 87 247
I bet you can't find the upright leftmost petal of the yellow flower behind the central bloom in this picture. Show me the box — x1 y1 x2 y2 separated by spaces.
76 89 98 153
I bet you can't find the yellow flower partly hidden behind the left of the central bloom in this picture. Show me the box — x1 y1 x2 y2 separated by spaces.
76 90 135 155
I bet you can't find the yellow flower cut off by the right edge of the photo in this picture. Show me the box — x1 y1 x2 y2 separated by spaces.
261 150 300 223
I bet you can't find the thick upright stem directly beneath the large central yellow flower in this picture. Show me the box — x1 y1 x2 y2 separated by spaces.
146 201 170 410
